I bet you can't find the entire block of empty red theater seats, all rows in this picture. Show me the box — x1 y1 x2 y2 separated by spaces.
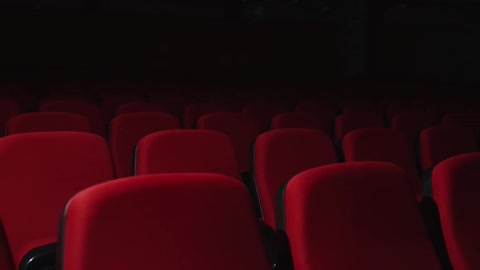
0 85 480 270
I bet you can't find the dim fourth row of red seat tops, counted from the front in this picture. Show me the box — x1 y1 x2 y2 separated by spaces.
0 93 478 135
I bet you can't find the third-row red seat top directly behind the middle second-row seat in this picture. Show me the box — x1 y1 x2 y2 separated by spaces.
271 112 333 134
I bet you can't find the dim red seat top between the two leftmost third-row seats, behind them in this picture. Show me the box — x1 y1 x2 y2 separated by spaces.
40 100 105 136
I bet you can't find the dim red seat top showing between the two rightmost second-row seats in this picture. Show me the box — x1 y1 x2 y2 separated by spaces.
392 112 434 147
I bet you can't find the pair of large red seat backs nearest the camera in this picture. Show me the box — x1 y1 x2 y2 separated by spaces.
61 165 441 270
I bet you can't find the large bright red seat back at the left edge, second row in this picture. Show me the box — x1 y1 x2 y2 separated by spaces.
0 132 113 266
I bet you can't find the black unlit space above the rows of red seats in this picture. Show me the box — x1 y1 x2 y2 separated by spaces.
0 0 480 89
